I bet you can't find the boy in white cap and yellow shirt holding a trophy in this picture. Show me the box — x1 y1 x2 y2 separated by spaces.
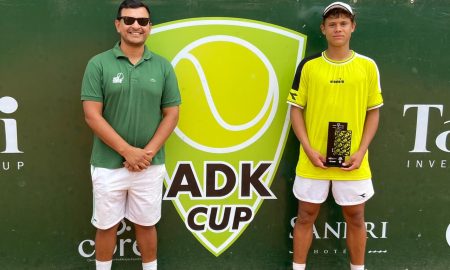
288 2 383 270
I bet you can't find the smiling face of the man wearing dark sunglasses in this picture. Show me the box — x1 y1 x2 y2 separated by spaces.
115 7 151 47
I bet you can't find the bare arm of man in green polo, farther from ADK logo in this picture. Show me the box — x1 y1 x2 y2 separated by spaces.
83 100 152 171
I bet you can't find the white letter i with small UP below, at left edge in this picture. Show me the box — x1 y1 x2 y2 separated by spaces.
0 96 25 172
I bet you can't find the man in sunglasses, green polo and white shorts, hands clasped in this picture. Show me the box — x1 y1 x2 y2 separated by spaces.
81 0 181 270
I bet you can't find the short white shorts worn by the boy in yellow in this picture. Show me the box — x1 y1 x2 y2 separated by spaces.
292 176 375 206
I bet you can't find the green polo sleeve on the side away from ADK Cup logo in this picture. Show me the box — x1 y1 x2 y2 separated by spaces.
81 59 103 102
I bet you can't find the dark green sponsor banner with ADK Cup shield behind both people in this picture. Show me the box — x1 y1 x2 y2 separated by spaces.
0 0 450 270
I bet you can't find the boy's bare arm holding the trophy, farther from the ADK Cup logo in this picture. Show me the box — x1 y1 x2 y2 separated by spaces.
342 108 380 171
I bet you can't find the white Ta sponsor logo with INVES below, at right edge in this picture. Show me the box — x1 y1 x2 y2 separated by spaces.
403 104 450 169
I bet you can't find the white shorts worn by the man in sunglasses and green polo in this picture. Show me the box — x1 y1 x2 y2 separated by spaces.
91 165 166 230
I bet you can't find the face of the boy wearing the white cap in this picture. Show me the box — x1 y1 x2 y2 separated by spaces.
320 14 356 47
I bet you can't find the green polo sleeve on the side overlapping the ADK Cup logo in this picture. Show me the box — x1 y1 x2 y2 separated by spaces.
161 59 181 108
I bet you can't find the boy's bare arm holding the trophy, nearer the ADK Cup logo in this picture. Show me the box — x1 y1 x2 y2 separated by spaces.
291 105 327 169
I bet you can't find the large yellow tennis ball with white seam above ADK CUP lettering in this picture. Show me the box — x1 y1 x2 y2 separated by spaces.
172 35 279 153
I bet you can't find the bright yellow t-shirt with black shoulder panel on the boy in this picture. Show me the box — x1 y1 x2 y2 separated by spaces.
287 51 383 180
